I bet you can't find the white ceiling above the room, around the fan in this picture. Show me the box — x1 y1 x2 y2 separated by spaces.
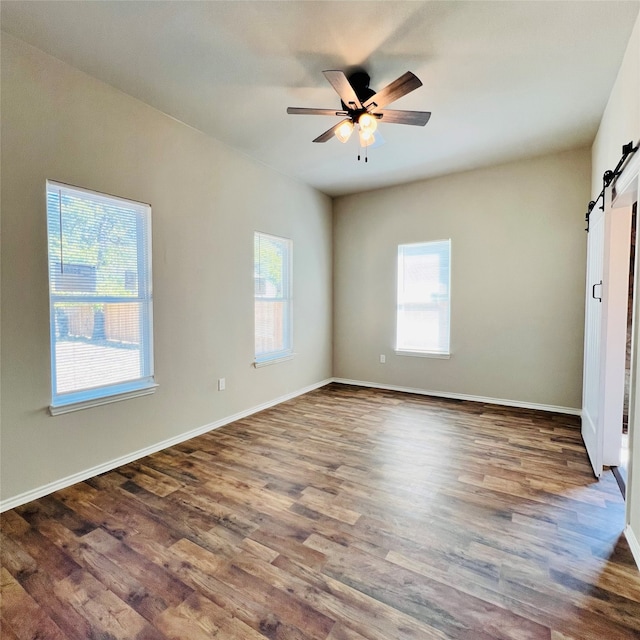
1 0 640 195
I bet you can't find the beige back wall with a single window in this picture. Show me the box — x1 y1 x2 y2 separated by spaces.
334 149 590 409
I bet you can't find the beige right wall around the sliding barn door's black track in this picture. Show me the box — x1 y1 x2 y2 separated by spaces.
591 17 640 565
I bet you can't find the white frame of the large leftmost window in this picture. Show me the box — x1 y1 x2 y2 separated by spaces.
46 180 158 415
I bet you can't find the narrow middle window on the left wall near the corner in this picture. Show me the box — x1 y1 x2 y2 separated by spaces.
253 231 292 366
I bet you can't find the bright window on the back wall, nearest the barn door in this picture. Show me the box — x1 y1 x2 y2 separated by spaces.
396 240 451 357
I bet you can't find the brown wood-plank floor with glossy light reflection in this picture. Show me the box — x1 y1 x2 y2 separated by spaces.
1 384 640 640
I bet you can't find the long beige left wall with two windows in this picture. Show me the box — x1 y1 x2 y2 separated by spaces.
1 34 332 500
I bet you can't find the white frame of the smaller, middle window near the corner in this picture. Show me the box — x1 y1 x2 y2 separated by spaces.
253 231 294 368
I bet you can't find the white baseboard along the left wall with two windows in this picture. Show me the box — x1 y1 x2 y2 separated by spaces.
0 378 333 513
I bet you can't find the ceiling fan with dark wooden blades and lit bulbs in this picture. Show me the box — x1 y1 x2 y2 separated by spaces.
287 70 431 147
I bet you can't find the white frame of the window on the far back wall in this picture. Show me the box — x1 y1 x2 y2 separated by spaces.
394 239 451 359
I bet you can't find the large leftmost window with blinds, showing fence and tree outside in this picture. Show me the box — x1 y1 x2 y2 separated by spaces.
47 181 155 415
